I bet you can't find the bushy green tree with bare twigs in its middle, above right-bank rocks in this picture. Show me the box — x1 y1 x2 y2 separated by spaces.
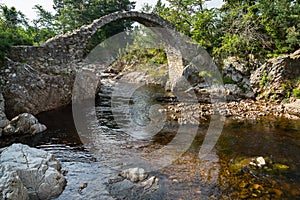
213 0 271 59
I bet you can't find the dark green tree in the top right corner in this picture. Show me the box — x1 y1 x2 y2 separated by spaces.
257 0 300 54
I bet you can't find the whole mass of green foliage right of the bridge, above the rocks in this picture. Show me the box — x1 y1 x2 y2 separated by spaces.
153 0 300 60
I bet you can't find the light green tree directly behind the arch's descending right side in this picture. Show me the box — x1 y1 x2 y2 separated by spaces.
153 0 219 53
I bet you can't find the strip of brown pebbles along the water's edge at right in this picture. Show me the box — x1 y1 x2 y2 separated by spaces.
167 100 300 124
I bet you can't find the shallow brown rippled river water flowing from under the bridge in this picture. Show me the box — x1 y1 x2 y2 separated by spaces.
2 80 300 199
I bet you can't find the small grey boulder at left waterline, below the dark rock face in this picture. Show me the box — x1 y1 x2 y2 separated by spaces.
3 113 47 135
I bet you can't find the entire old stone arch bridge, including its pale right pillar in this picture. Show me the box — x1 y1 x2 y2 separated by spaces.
9 11 210 87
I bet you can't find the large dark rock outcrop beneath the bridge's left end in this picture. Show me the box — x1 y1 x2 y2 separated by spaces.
1 61 74 118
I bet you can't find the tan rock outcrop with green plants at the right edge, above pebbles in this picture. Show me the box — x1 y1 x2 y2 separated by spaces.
250 49 300 100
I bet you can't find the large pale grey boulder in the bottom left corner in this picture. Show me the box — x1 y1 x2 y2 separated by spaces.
0 144 66 200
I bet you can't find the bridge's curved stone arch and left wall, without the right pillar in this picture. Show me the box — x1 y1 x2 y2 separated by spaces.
9 11 174 67
